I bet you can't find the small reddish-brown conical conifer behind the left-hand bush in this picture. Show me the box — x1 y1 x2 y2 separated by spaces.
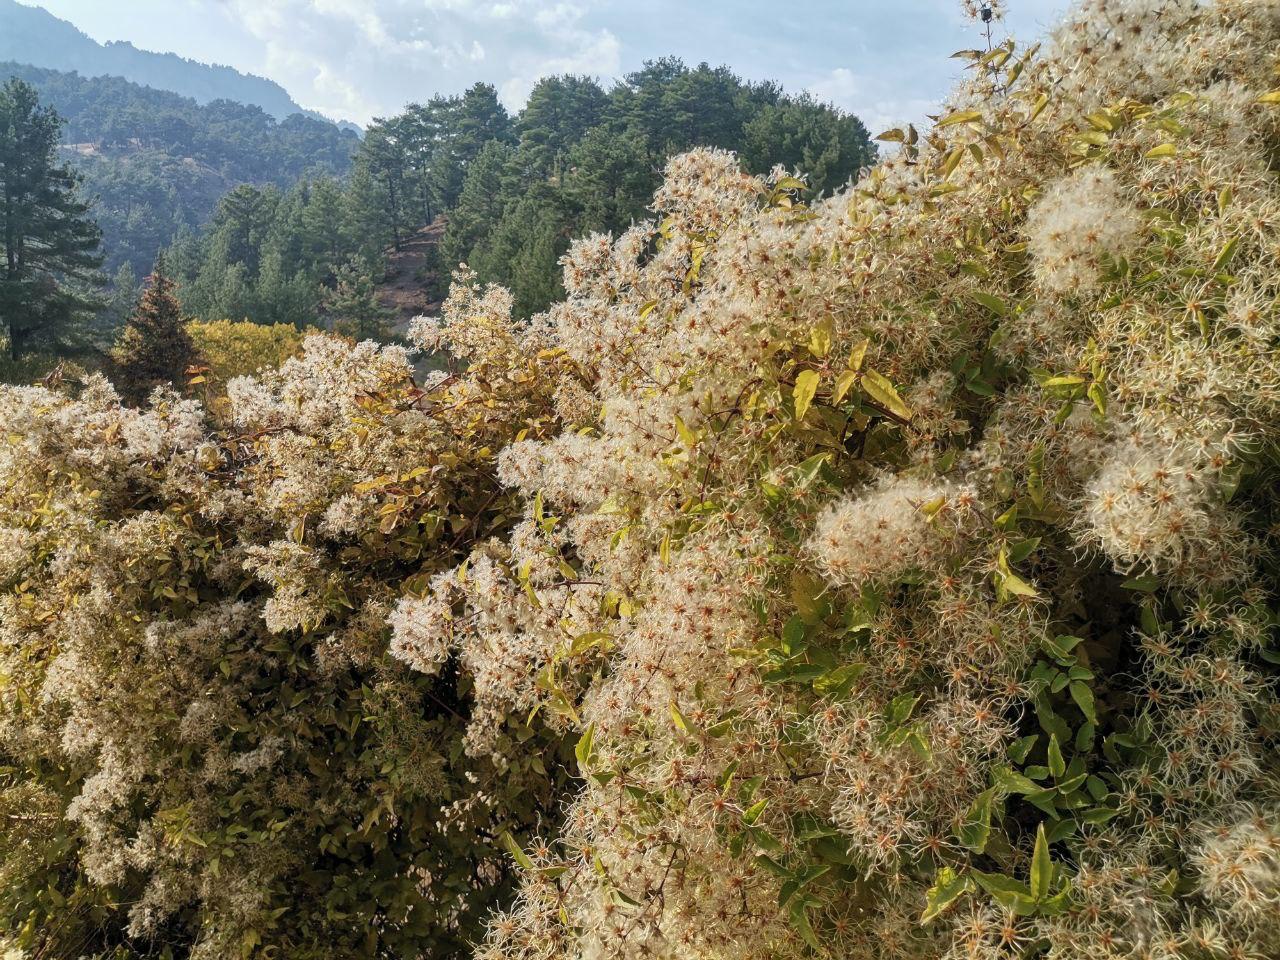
115 253 197 404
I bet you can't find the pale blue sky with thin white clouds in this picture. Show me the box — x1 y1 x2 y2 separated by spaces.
23 0 1066 134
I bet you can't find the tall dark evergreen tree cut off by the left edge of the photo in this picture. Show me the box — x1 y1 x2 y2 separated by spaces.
0 79 102 361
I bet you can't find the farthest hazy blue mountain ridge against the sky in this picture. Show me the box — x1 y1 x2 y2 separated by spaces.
0 0 319 120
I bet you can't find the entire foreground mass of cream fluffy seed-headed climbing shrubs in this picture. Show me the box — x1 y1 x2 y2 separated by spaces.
0 0 1280 960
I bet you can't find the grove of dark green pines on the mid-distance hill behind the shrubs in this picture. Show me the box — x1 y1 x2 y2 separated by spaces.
167 66 874 323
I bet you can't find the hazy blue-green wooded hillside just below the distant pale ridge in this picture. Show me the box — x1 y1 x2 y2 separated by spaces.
0 63 358 276
